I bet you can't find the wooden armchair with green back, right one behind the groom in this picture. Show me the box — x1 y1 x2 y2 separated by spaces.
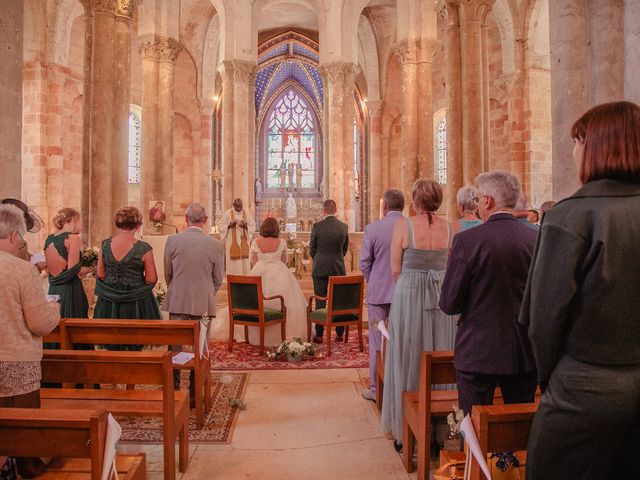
307 275 364 356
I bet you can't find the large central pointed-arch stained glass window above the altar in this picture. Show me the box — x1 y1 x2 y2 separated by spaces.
267 89 317 190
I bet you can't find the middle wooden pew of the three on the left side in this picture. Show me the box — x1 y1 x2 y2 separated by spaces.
40 350 189 480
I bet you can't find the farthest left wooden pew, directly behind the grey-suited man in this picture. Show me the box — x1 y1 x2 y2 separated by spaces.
60 318 211 429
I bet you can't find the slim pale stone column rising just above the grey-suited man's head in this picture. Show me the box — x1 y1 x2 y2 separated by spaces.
198 100 215 210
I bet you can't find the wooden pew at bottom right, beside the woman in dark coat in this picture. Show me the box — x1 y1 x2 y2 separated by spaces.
471 397 540 480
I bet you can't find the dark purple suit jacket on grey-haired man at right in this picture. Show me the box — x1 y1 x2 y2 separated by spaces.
440 213 537 375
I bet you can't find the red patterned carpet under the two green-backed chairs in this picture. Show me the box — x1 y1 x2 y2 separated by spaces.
209 329 369 370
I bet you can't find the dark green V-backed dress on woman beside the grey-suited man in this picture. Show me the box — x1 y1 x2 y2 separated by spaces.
93 238 162 351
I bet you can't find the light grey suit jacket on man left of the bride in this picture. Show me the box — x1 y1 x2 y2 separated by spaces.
163 227 224 316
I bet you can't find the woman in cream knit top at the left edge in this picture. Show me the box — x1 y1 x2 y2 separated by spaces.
0 205 60 478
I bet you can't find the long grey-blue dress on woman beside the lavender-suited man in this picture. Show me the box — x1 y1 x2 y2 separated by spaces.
381 219 457 440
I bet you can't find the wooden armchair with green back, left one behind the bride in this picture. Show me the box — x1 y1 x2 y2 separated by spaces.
227 275 287 355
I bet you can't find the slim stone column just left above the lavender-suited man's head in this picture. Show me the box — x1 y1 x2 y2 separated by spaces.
367 100 384 222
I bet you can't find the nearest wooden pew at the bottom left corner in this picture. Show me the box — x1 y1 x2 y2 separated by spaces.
0 408 146 480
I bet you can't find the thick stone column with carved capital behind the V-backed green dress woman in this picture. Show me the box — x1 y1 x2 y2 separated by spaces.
140 37 183 230
